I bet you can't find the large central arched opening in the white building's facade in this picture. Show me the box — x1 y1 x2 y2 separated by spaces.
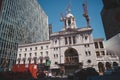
64 48 79 74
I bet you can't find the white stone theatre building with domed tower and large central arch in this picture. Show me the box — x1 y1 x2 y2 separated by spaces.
16 9 119 74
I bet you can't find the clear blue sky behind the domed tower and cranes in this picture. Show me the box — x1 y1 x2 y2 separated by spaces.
38 0 105 39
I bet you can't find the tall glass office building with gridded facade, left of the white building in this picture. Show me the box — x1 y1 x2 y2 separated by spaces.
0 0 49 67
